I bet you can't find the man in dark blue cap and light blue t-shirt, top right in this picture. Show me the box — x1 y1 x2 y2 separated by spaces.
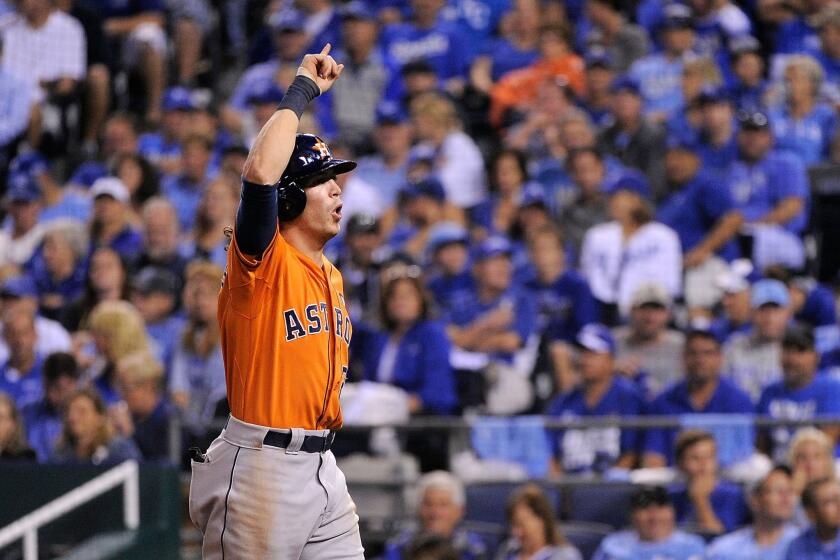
629 2 695 122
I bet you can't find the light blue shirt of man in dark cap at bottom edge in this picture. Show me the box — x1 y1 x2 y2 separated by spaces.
592 530 706 560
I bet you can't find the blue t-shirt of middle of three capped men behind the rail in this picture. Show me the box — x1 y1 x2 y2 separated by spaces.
644 378 755 465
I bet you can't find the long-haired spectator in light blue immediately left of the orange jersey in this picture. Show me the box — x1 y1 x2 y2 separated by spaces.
169 261 227 434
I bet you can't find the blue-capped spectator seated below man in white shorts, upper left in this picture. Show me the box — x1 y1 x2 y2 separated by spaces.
137 86 197 174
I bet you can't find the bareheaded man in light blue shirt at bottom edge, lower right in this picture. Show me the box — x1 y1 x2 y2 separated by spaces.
706 466 799 560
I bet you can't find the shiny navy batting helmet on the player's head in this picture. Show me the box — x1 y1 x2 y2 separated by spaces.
277 134 356 222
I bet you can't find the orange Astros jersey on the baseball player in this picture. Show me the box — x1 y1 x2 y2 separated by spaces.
219 225 352 430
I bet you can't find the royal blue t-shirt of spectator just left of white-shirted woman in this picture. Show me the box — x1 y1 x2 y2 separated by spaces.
526 270 598 342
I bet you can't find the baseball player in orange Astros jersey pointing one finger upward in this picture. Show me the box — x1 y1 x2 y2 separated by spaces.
190 44 363 560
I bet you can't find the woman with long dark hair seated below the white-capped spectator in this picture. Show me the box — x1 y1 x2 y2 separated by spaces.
60 247 128 332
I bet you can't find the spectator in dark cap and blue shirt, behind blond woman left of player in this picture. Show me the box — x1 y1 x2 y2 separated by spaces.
131 266 184 375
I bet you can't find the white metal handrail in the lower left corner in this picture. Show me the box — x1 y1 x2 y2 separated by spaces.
0 461 140 560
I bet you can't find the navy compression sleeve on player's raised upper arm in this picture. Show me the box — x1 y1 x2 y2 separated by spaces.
236 180 277 257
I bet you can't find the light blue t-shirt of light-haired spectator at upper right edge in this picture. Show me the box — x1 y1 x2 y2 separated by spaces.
768 104 837 167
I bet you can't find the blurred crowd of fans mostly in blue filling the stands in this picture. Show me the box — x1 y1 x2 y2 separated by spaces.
0 0 840 559
